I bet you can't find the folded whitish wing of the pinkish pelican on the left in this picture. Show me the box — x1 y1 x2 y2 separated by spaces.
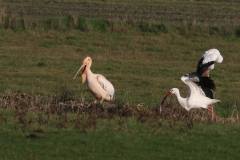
94 74 115 100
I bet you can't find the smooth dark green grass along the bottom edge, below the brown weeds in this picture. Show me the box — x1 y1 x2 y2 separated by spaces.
0 126 239 159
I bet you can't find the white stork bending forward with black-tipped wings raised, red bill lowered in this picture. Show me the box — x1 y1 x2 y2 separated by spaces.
162 55 221 121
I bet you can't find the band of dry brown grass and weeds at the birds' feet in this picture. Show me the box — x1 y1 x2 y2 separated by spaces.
0 92 240 125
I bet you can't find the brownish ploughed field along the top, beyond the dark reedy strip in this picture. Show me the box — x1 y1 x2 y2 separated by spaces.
2 0 240 25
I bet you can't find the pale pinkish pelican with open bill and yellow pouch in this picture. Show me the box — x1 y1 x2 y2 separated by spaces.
73 57 115 104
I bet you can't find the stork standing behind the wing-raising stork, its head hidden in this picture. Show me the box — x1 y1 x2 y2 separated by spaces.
198 48 223 77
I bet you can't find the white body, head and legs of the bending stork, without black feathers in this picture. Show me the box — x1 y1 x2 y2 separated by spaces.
162 80 221 121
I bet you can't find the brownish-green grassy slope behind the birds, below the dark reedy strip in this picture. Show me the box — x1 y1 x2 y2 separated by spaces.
0 30 240 116
